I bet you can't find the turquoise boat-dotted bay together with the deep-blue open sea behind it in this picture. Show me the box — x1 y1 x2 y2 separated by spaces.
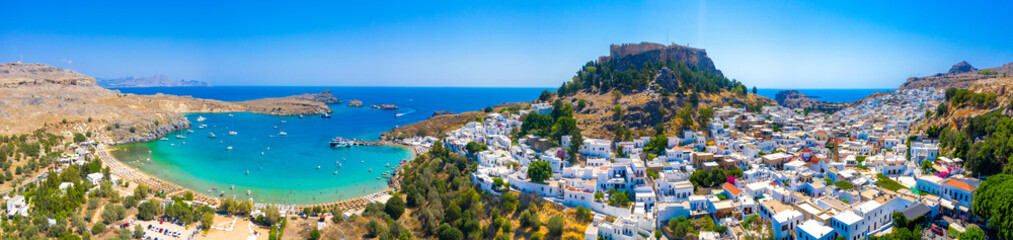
113 87 544 204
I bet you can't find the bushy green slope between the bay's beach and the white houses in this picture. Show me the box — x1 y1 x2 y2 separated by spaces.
372 142 590 240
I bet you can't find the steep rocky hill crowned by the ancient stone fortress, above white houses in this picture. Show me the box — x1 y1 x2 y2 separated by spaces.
540 43 775 140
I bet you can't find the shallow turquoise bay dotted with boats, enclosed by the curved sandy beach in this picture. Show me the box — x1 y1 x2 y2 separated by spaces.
113 105 412 204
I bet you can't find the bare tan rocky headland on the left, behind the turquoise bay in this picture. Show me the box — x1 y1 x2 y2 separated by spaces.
0 63 336 143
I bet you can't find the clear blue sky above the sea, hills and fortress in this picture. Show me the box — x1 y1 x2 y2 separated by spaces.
0 1 1013 88
